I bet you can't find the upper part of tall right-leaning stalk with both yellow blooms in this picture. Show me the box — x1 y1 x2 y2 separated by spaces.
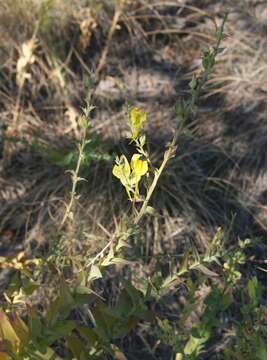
113 14 227 225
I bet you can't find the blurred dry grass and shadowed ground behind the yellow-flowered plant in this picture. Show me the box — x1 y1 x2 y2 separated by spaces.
0 0 267 294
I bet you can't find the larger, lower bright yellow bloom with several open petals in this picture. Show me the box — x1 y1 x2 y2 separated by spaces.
112 154 148 200
